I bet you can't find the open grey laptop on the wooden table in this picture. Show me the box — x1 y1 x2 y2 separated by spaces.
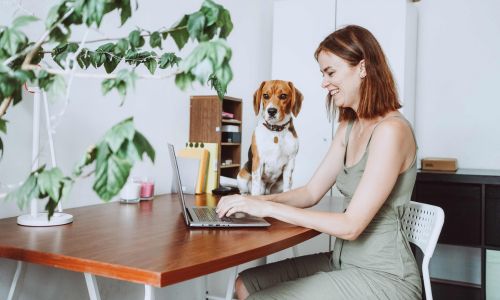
168 144 271 228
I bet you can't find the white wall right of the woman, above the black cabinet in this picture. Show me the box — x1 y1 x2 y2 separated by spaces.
416 0 500 169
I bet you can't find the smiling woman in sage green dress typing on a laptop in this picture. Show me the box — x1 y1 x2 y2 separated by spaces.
217 26 421 299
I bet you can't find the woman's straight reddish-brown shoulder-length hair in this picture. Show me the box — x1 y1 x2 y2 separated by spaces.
314 25 401 122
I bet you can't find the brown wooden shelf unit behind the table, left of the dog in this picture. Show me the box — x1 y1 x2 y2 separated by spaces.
189 95 243 185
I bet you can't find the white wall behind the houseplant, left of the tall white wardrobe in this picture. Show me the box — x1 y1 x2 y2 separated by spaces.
0 0 272 299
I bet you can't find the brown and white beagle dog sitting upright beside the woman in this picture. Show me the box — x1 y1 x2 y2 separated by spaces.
237 80 303 195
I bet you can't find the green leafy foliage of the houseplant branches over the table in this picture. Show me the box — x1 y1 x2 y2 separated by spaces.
0 0 233 220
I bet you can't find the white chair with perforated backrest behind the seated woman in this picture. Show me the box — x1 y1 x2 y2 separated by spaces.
402 201 444 300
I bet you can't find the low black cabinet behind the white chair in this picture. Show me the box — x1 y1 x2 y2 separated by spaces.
412 169 500 300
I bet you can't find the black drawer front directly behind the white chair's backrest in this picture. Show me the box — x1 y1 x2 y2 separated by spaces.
415 181 481 246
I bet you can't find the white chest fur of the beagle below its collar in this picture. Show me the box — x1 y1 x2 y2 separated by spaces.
255 124 299 182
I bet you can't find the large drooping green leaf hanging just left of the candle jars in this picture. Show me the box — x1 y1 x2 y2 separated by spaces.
93 154 132 201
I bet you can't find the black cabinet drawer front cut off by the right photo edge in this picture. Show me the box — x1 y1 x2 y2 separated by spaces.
485 185 500 247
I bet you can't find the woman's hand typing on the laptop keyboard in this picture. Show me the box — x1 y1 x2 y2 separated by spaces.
215 195 271 218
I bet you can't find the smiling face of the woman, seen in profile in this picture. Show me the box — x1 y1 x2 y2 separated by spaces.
318 51 366 111
